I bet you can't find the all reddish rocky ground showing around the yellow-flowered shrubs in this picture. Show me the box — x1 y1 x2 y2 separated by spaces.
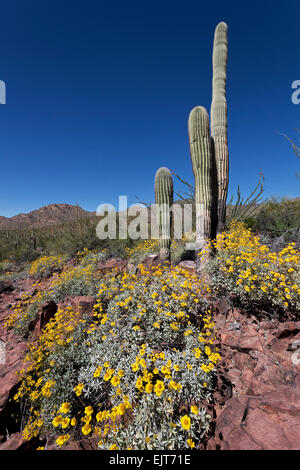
0 259 300 450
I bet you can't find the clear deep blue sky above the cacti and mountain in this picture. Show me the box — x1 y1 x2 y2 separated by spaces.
0 0 300 216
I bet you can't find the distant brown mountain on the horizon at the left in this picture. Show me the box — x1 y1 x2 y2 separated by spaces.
0 204 95 230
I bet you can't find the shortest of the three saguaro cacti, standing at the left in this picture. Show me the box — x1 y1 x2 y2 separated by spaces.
155 167 173 261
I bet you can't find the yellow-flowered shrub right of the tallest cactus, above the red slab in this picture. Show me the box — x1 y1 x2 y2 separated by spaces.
202 221 300 310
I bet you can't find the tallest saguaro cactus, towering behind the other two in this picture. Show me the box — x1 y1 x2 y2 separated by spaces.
210 22 229 233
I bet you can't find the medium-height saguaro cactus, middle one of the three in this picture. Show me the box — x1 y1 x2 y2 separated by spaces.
188 106 214 255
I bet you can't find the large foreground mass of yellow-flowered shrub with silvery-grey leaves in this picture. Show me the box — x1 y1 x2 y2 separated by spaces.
15 267 220 450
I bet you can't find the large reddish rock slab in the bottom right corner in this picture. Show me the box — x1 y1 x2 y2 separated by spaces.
206 307 300 450
